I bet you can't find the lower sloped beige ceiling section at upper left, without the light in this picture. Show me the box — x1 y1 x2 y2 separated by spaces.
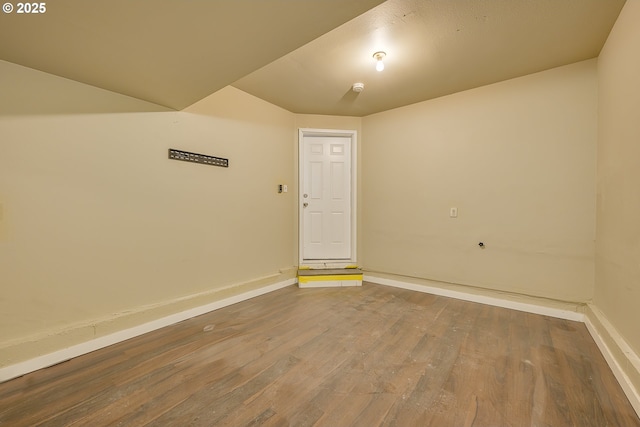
0 0 383 110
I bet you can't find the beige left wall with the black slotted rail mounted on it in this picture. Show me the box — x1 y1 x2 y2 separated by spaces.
0 63 295 366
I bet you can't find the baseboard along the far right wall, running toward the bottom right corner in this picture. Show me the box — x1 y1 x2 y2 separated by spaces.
584 305 640 417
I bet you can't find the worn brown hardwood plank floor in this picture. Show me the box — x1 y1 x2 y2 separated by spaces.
0 283 640 427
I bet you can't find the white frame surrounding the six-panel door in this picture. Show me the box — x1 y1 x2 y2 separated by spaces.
297 128 358 268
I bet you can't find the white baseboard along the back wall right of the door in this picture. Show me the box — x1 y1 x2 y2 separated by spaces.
363 273 584 322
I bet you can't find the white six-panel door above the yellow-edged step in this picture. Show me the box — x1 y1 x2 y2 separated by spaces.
300 133 352 262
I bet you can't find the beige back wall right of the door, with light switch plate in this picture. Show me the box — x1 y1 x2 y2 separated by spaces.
361 60 597 302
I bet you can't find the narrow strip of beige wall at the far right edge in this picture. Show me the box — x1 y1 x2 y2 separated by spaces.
594 1 640 362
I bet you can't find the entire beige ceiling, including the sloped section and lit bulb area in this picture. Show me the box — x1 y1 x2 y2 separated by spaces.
0 0 624 116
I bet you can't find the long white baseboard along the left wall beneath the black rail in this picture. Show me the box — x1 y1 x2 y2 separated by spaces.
0 278 297 382
